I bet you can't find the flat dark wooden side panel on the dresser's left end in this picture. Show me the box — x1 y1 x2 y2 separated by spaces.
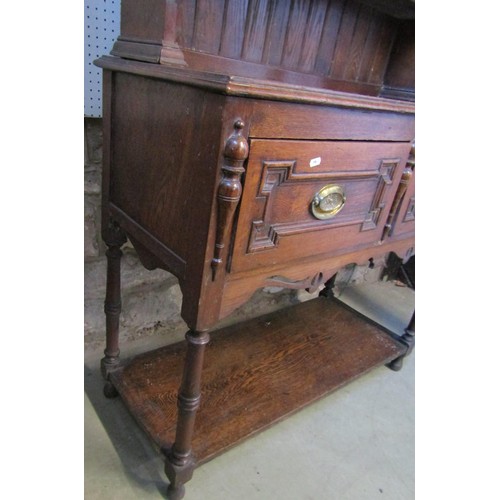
110 72 224 278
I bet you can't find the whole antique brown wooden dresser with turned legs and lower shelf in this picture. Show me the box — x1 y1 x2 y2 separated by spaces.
96 0 415 498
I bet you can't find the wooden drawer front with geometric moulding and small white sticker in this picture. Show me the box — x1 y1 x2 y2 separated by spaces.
231 139 410 272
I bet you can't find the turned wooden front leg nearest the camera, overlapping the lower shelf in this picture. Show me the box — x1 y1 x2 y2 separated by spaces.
165 330 210 500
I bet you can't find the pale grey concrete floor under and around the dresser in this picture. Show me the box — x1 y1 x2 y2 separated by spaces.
85 282 415 500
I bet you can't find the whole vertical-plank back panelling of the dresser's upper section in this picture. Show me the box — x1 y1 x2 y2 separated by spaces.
154 0 397 89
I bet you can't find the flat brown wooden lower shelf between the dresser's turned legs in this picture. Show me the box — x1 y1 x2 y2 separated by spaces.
111 297 405 463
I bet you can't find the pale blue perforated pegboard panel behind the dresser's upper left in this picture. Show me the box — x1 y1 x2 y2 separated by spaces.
84 0 120 117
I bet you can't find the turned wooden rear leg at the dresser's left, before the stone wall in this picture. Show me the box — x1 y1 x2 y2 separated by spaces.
101 224 126 397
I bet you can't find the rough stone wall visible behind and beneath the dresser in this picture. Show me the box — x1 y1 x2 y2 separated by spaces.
84 118 384 349
